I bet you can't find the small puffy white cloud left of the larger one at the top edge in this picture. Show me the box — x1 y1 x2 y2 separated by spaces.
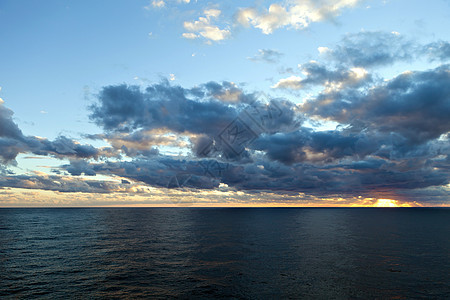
182 9 231 42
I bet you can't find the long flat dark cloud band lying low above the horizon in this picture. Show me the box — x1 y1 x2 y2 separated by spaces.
51 139 448 201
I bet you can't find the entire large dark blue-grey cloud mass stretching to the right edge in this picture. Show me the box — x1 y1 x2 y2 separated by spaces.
80 72 450 204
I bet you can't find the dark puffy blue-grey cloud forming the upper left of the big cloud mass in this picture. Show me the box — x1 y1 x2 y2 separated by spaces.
91 82 301 159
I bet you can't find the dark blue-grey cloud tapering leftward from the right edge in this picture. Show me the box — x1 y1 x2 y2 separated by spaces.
302 65 450 143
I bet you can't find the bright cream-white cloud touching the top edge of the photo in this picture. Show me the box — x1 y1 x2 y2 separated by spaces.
237 0 361 34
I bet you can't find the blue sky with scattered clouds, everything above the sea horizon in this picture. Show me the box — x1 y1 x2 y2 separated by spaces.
0 0 450 207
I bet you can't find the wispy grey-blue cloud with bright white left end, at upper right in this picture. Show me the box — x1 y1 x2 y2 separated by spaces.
272 31 450 94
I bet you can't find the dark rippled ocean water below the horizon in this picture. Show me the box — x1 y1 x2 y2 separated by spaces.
0 208 450 299
